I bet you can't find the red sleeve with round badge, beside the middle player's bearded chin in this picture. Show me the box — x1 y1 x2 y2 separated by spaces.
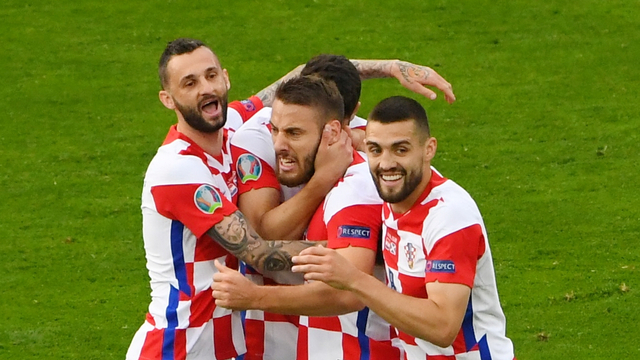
231 145 280 194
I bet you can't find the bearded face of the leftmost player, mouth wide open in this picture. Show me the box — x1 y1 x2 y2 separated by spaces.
160 46 230 133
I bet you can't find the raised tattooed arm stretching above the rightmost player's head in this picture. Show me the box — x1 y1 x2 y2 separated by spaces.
351 60 456 103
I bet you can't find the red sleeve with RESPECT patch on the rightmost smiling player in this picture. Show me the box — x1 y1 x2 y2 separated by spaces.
425 224 485 288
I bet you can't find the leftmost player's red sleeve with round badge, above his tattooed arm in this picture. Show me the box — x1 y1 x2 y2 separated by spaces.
151 184 238 238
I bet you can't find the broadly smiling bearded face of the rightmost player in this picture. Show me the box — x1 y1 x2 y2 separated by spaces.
365 120 436 212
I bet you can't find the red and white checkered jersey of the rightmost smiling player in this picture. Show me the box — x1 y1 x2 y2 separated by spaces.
383 169 514 360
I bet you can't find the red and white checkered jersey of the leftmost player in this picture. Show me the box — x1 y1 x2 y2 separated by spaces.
127 98 262 359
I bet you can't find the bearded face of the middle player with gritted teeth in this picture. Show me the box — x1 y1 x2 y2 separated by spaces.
271 99 324 187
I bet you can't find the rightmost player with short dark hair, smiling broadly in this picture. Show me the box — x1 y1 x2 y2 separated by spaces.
293 96 514 360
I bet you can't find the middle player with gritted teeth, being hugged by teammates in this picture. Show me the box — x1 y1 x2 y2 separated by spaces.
212 76 401 360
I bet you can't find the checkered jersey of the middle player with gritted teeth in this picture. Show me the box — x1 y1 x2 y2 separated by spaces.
298 152 401 360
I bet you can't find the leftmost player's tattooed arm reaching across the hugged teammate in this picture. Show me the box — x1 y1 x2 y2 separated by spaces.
207 211 323 284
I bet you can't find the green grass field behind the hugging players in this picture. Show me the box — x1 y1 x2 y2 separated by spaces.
0 0 640 360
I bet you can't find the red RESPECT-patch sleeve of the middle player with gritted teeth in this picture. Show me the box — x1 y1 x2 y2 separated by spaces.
327 205 382 251
